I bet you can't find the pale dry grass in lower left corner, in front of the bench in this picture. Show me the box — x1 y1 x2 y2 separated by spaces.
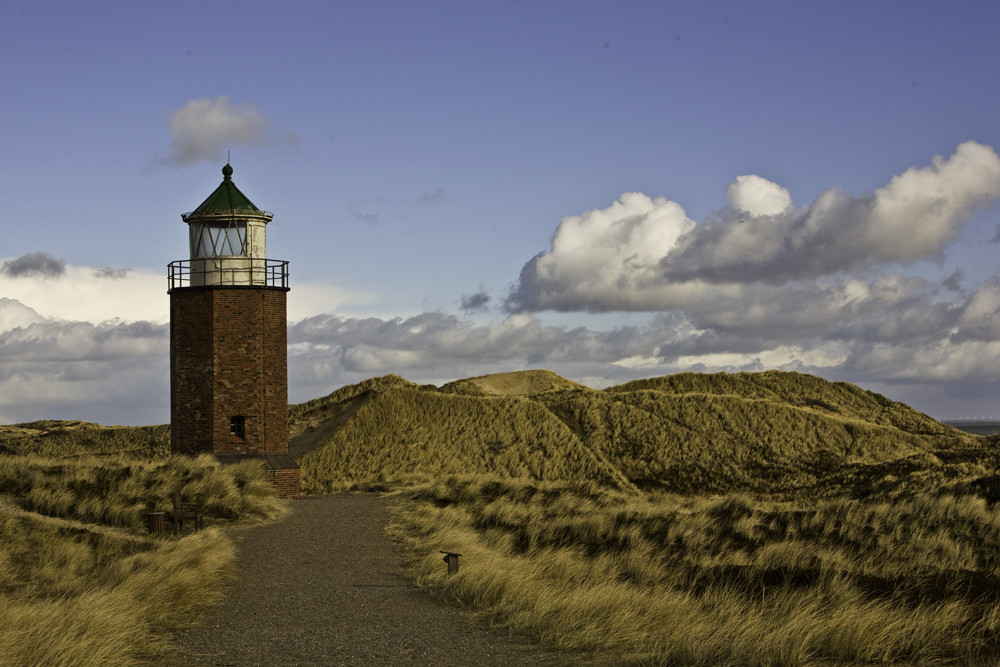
0 502 234 666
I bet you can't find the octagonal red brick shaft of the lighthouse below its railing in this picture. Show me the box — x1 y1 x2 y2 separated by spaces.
170 287 288 454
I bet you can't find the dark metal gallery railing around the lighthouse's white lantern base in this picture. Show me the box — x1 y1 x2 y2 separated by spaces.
167 257 288 291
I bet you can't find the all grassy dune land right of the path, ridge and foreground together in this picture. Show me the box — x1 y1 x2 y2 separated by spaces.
290 372 1000 665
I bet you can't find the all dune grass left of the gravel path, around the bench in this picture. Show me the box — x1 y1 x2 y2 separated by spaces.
0 455 281 665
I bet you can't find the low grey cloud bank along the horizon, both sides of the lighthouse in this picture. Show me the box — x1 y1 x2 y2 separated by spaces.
0 274 1000 424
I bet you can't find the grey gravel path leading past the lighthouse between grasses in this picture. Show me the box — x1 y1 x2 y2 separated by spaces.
165 494 584 667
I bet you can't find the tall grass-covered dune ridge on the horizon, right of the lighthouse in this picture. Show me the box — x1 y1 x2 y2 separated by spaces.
290 371 982 495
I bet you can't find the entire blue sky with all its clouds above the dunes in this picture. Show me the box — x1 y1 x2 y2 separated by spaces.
0 0 1000 424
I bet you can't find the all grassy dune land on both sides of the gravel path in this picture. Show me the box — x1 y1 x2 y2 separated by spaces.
0 371 1000 666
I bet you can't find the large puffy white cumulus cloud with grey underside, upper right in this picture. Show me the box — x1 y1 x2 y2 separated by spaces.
505 141 1000 312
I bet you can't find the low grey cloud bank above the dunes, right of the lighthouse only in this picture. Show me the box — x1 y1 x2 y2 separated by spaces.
280 275 1000 415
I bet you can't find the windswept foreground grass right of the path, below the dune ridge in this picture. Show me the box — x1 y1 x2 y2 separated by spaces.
393 477 1000 665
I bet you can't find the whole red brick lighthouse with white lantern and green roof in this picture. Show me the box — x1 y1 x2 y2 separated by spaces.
167 164 299 496
